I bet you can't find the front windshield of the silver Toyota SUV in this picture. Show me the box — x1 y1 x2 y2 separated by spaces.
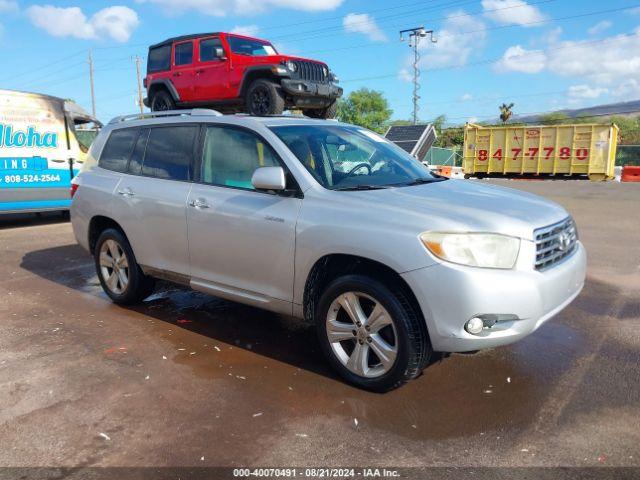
271 125 442 190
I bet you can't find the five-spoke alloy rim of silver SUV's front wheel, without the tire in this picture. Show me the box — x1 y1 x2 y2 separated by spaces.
326 292 398 378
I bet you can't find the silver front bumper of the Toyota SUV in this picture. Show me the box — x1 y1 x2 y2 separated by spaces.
402 243 587 352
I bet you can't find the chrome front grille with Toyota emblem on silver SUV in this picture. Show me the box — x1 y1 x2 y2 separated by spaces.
534 217 578 270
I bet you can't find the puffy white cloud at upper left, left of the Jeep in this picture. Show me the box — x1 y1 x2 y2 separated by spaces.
27 5 140 42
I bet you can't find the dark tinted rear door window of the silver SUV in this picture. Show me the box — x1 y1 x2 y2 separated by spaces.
142 125 199 181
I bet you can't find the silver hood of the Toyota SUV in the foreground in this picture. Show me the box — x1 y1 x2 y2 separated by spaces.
332 180 569 240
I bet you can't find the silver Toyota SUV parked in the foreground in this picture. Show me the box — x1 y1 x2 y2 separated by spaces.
71 110 586 391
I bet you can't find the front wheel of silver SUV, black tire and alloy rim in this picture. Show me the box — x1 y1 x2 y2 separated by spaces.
315 275 432 392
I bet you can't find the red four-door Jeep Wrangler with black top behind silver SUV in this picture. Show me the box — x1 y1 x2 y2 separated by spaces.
144 33 342 118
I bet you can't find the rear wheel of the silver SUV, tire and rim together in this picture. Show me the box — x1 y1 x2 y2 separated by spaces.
94 228 155 305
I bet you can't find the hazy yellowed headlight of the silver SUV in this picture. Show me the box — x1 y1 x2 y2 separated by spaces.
420 232 520 268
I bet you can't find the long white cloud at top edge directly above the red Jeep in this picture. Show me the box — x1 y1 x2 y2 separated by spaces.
147 0 344 17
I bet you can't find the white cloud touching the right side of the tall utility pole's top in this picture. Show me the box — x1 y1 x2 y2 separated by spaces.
418 10 486 68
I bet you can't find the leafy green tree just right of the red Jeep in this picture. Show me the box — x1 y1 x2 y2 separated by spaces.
337 88 393 133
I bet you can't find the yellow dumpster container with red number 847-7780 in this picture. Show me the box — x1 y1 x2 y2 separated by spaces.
463 124 618 181
